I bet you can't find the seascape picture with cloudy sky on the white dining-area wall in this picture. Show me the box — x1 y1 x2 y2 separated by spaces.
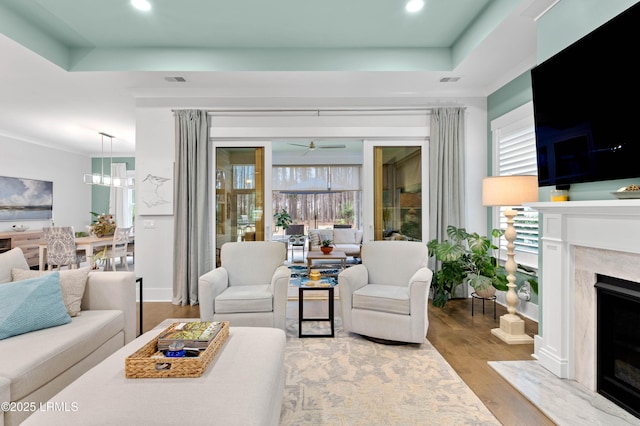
0 176 53 221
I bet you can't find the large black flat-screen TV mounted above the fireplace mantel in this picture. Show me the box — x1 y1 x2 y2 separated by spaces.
531 3 640 186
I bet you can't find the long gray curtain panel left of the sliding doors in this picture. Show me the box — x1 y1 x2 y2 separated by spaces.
173 110 213 305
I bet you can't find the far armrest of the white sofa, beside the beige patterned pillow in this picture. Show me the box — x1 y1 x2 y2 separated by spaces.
80 271 136 344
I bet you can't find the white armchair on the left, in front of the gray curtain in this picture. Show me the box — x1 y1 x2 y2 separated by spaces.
198 241 291 330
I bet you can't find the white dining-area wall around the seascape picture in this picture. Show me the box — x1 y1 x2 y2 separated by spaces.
0 135 91 231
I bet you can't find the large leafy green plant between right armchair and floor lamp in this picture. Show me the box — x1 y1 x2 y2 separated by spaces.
427 225 507 307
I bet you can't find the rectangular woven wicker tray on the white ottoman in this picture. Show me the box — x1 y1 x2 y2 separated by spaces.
124 321 229 379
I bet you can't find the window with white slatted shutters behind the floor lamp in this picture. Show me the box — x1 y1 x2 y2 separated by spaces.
491 102 538 268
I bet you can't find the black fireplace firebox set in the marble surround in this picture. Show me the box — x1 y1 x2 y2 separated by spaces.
595 275 640 418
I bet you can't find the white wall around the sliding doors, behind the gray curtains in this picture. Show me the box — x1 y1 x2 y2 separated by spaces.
136 98 487 301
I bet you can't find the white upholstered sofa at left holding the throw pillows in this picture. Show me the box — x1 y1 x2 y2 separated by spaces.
0 248 136 425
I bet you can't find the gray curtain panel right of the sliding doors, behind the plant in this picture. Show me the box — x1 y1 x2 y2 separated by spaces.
429 108 467 297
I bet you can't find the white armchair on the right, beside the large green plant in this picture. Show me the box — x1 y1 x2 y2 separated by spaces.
338 241 433 343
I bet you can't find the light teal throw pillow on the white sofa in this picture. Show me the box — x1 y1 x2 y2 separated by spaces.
0 271 71 339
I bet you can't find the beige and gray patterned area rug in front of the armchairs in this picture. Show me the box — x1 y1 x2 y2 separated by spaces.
280 318 500 426
